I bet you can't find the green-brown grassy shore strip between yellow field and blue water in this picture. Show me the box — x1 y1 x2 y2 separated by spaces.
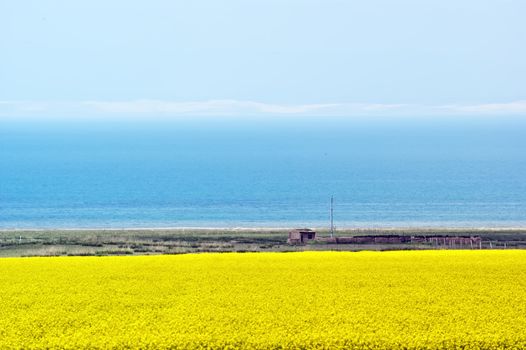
0 225 526 257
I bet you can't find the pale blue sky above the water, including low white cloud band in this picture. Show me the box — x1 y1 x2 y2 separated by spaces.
0 0 526 117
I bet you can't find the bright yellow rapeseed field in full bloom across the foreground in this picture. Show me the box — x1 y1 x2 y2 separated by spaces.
0 250 526 349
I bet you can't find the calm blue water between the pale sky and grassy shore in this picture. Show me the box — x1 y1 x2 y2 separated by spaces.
0 117 526 229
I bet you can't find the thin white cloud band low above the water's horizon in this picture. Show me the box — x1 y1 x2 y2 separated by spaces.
0 99 526 118
